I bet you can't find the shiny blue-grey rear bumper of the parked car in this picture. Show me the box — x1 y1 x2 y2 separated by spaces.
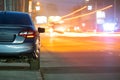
0 43 35 56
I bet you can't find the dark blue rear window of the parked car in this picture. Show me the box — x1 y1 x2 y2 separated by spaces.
0 12 32 25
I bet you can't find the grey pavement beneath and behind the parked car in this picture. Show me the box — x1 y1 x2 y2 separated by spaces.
0 63 42 80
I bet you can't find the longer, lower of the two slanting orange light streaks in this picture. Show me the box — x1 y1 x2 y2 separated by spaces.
64 5 113 21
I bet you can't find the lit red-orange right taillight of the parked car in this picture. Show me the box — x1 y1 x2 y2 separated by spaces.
19 30 36 38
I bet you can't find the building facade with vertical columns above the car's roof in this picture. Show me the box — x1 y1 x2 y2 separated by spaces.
0 0 32 12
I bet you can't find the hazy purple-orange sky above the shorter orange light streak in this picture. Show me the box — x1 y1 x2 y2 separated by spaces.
40 0 83 16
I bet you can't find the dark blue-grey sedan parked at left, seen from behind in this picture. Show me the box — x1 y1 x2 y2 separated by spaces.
0 11 44 69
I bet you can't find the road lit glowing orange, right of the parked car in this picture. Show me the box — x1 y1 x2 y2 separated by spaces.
41 33 120 80
